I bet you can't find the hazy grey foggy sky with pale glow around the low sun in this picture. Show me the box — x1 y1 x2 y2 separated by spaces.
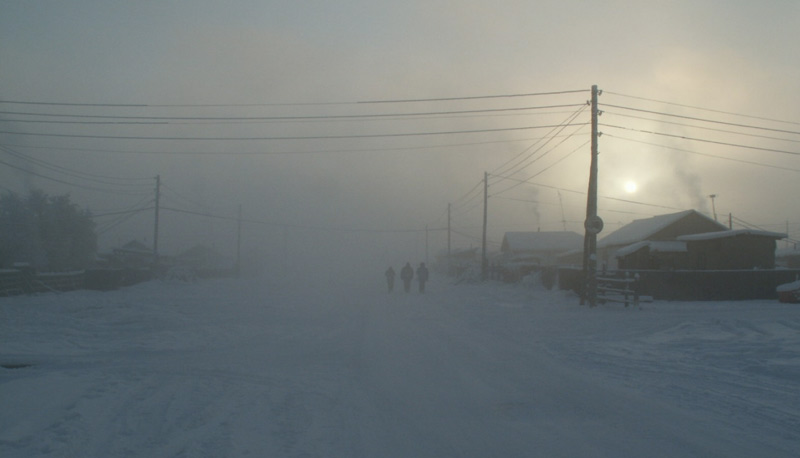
0 0 800 276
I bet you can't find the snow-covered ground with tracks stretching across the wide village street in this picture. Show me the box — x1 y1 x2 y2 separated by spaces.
0 274 800 458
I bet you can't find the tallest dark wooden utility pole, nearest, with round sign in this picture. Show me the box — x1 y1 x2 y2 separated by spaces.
581 85 603 307
